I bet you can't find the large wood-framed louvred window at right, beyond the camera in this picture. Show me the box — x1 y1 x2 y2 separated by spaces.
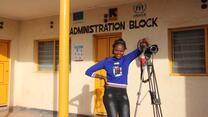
169 26 208 75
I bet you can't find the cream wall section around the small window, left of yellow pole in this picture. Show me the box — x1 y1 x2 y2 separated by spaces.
15 16 58 110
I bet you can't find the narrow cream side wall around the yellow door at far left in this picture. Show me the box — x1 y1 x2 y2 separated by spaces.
0 17 20 105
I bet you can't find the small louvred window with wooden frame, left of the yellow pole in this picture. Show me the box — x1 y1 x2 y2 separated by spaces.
36 40 70 71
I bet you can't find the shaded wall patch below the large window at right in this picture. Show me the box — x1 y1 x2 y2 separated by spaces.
185 76 208 117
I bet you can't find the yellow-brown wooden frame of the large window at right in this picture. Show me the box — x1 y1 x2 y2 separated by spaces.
168 25 208 76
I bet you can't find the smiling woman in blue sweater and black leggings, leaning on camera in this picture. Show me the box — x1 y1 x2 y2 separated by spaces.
85 38 146 117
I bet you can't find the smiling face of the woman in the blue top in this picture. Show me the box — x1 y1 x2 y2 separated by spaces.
113 44 125 59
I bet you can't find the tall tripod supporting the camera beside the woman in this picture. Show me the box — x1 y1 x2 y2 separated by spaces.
134 55 163 117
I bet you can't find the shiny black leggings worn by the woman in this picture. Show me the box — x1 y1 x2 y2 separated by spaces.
103 86 130 117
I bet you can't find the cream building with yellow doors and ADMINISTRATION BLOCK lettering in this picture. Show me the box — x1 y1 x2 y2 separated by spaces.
0 0 208 117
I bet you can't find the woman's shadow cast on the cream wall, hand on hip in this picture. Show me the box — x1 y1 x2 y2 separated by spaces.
69 85 94 114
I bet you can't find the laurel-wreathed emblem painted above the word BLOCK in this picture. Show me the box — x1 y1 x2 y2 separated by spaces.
133 2 147 18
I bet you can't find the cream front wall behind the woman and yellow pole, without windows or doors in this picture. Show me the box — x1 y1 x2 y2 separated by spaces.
0 0 208 117
